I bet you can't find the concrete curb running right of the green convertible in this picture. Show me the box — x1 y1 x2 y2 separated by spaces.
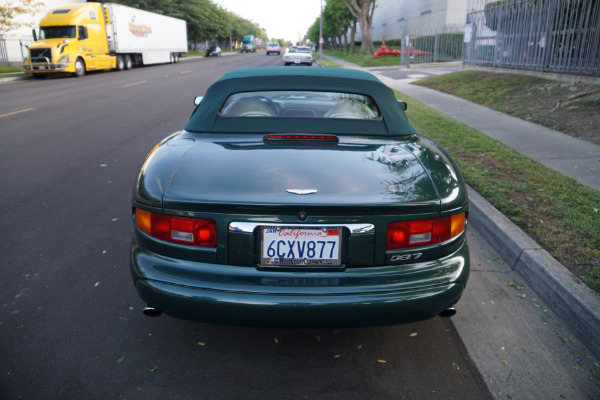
469 187 600 358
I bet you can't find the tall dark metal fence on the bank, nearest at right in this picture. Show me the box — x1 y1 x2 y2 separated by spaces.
464 0 600 76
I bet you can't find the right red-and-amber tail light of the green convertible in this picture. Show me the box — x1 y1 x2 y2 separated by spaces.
387 213 465 249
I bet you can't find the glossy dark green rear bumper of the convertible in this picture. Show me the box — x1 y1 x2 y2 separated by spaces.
131 239 469 328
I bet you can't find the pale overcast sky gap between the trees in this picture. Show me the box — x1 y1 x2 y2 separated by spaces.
213 0 321 42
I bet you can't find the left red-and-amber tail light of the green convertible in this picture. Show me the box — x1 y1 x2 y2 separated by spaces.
135 208 217 247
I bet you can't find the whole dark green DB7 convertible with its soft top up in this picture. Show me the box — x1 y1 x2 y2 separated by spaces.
130 67 469 328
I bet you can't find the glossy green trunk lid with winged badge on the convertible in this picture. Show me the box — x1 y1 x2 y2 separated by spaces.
163 139 440 212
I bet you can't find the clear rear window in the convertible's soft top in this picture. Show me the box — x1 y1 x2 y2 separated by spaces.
219 91 381 120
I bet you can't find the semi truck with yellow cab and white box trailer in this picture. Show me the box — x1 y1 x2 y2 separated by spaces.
22 3 187 78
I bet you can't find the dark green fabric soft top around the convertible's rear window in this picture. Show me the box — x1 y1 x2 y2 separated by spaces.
185 67 415 135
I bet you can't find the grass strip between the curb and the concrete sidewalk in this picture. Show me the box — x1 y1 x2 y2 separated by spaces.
396 92 600 292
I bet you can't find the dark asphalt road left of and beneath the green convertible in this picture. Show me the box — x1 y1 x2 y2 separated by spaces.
0 53 490 400
